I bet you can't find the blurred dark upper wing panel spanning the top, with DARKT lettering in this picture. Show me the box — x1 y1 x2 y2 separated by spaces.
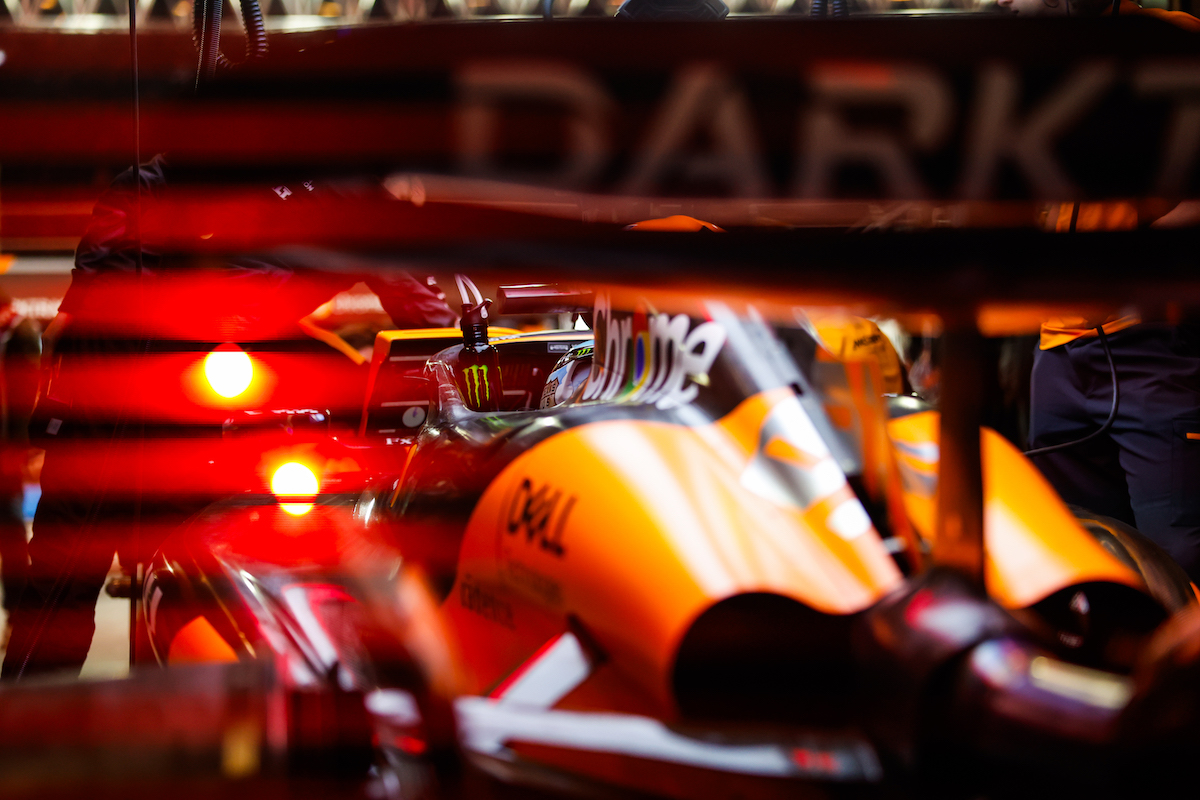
0 17 1200 225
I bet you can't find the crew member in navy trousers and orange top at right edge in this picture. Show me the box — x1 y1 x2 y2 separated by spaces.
998 0 1200 582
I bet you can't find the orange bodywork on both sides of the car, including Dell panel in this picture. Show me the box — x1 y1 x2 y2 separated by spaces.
444 335 1144 718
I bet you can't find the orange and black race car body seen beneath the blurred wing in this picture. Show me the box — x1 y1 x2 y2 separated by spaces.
136 289 1198 798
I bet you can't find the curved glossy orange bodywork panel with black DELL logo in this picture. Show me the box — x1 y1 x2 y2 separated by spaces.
444 389 901 716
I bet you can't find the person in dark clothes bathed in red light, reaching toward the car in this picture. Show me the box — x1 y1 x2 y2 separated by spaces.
0 157 456 680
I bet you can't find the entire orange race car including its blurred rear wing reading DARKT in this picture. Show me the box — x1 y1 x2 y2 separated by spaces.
7 0 1200 800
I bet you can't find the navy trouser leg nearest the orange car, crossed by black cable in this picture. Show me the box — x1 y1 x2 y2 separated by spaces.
1030 343 1134 524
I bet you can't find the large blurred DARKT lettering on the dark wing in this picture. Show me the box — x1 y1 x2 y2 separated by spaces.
454 58 1200 200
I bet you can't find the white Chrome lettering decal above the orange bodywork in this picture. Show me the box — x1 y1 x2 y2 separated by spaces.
583 296 726 408
